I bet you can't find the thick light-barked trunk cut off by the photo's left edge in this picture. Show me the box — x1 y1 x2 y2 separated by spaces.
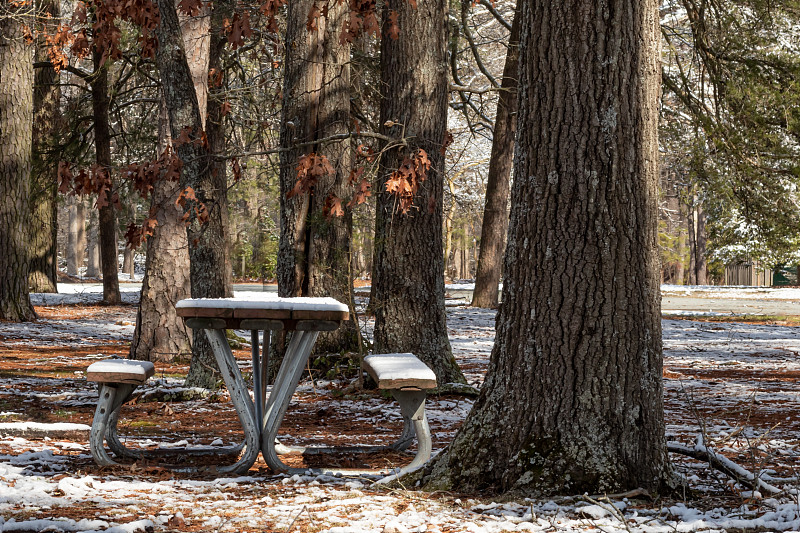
0 9 36 321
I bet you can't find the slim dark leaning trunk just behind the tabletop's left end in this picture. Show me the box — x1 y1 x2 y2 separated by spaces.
156 0 232 388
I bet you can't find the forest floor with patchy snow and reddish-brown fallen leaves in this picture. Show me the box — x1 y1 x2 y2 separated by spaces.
0 291 800 533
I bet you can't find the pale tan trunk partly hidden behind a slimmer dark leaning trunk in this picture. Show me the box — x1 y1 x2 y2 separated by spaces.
131 2 211 361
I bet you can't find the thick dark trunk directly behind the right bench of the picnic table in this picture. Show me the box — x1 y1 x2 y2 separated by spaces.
370 0 466 385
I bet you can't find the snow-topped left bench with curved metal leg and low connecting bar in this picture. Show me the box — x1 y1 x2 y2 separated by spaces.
86 359 243 466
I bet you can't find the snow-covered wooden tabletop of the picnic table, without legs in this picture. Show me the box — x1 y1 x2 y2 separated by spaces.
175 293 349 321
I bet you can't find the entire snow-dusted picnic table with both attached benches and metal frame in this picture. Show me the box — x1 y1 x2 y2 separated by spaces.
87 293 436 481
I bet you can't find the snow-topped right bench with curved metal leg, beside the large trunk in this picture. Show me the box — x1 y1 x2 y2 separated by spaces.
364 353 436 482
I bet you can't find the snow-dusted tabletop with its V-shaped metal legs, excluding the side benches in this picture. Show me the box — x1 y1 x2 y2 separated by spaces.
175 293 349 473
